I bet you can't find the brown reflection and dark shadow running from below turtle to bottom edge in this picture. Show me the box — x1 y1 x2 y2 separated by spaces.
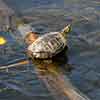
30 48 89 100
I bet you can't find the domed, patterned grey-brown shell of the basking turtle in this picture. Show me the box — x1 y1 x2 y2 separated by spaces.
28 32 67 59
